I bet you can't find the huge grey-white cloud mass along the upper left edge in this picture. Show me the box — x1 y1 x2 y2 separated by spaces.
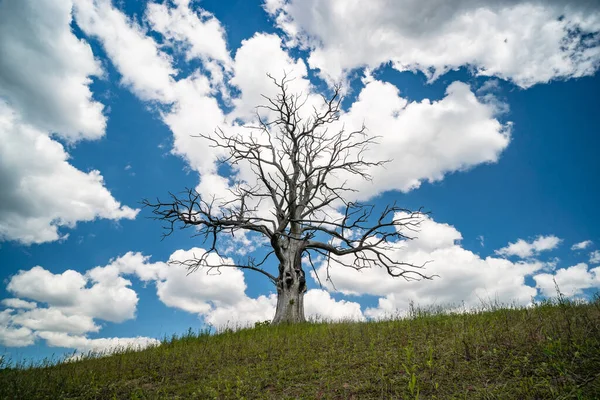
0 0 138 244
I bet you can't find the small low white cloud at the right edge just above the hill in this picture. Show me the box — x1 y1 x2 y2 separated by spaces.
533 263 600 297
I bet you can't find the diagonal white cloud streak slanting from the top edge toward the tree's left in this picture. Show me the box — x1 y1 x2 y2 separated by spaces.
75 0 230 178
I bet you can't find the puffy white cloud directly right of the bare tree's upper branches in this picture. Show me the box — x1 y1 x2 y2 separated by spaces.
340 80 511 199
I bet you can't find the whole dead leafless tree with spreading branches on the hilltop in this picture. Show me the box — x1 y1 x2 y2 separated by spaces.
144 76 431 323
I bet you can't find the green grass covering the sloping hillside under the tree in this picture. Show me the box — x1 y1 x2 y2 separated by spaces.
0 296 600 399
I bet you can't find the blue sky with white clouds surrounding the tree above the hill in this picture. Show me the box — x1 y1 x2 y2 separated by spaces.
0 0 600 359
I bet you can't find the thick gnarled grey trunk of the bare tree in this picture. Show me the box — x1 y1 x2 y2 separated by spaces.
272 239 306 324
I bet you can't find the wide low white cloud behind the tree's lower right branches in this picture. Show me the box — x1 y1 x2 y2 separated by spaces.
311 217 544 317
